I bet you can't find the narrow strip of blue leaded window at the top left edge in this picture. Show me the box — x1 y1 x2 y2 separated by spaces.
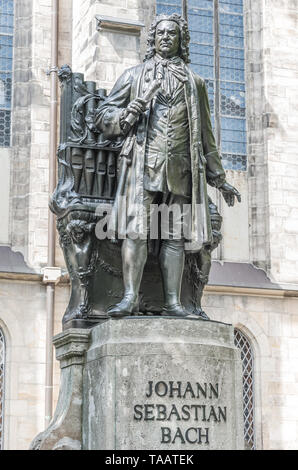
0 0 14 147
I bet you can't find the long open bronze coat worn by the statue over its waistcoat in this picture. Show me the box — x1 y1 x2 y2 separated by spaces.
96 59 225 252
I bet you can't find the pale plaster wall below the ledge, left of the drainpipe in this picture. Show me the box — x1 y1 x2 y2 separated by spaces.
0 281 46 449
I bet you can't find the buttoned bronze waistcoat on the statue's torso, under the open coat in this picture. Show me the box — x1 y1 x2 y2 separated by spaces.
144 69 191 196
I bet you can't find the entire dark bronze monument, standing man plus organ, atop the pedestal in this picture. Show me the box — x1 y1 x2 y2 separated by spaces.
51 15 240 327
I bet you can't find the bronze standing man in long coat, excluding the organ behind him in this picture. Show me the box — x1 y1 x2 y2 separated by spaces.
95 14 241 317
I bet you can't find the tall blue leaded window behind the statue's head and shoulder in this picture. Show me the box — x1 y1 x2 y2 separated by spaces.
156 0 247 171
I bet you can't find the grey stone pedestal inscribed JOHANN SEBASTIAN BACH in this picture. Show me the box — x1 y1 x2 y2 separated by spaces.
32 317 244 451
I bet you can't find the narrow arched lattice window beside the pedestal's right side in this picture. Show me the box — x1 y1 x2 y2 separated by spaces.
234 329 255 450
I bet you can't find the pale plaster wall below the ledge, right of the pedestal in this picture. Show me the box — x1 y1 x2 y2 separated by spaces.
203 293 298 450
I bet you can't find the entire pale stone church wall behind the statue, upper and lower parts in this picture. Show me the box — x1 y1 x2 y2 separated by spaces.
0 0 298 449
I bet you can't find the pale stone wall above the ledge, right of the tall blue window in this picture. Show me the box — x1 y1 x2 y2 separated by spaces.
246 0 298 285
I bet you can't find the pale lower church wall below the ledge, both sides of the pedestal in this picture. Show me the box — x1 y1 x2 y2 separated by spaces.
0 281 298 449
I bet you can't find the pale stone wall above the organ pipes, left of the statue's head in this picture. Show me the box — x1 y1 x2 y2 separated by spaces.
72 0 155 90
